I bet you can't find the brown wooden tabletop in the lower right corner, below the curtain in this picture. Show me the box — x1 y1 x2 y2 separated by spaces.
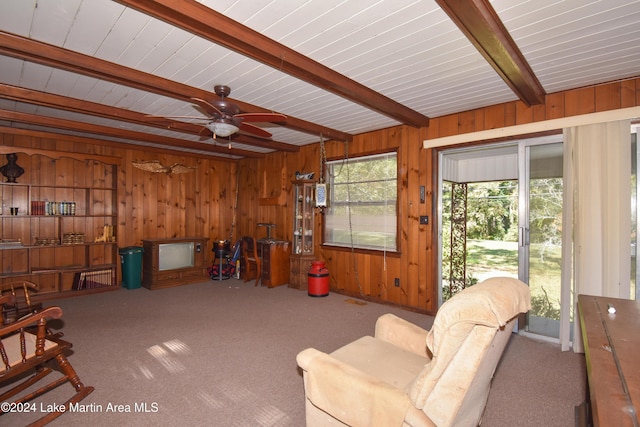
578 295 640 427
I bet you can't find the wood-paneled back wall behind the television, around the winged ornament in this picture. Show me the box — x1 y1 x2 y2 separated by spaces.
0 129 237 260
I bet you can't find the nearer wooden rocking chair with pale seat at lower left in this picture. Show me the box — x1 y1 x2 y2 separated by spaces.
0 294 93 426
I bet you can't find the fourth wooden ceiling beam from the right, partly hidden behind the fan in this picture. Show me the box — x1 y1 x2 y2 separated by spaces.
0 83 300 152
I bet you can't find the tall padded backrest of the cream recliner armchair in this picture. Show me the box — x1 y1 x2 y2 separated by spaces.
408 277 531 427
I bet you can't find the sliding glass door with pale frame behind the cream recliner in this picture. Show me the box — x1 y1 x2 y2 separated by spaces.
439 135 562 339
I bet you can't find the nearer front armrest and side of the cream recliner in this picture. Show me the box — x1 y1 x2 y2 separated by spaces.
296 348 426 426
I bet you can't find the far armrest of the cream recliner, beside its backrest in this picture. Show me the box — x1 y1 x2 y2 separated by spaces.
375 313 431 359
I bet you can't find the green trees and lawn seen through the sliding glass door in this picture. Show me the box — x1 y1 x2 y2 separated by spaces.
442 178 562 320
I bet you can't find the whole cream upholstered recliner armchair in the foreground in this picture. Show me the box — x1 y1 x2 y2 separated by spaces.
297 277 531 427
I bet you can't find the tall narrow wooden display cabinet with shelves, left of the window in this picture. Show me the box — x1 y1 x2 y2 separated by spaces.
289 180 316 289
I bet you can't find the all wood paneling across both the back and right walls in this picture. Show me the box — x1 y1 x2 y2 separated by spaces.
0 79 640 312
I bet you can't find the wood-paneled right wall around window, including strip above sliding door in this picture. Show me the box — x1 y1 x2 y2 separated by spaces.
238 79 640 312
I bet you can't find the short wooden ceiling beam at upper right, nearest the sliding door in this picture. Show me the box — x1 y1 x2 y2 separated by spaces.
436 0 545 106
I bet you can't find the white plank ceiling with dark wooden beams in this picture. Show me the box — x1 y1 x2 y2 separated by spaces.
0 0 640 158
